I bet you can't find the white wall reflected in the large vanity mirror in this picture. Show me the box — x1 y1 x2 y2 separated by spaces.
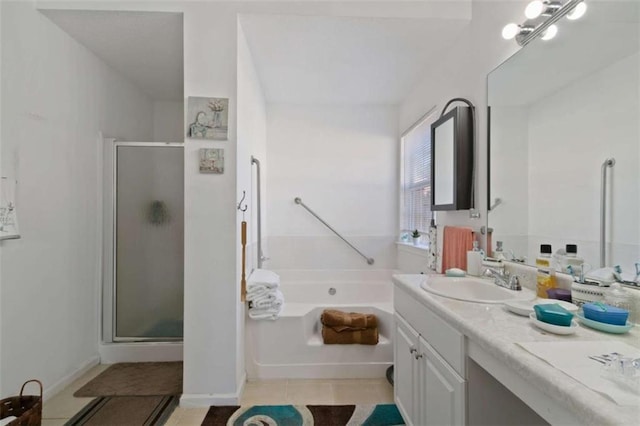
528 53 640 271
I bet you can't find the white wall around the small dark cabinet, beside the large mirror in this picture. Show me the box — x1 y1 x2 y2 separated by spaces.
400 0 527 264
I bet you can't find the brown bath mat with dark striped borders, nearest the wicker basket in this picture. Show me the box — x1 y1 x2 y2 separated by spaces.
65 396 178 426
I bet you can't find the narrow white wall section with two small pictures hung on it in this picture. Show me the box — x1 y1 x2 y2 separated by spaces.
182 3 243 405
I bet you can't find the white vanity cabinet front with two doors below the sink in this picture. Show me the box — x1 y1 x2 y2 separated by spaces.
394 282 466 426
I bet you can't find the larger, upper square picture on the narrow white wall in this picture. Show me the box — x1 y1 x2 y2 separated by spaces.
187 97 229 141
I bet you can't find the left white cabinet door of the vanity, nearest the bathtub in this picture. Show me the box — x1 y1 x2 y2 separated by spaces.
393 315 420 425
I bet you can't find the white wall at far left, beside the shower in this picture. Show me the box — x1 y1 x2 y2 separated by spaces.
0 2 152 397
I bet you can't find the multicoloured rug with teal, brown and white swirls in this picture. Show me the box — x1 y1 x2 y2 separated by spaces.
202 404 404 426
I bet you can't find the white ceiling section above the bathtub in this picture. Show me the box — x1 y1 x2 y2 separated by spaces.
240 15 469 104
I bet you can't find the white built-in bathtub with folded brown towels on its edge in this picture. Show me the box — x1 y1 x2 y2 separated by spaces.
245 270 394 379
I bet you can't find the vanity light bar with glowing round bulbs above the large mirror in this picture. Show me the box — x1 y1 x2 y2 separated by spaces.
502 0 587 46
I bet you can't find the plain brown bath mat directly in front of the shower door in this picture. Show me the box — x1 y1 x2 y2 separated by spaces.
73 362 182 397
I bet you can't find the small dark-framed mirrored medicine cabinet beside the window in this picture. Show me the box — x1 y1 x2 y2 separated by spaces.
431 107 473 210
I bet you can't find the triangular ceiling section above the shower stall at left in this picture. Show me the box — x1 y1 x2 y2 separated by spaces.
42 10 184 101
